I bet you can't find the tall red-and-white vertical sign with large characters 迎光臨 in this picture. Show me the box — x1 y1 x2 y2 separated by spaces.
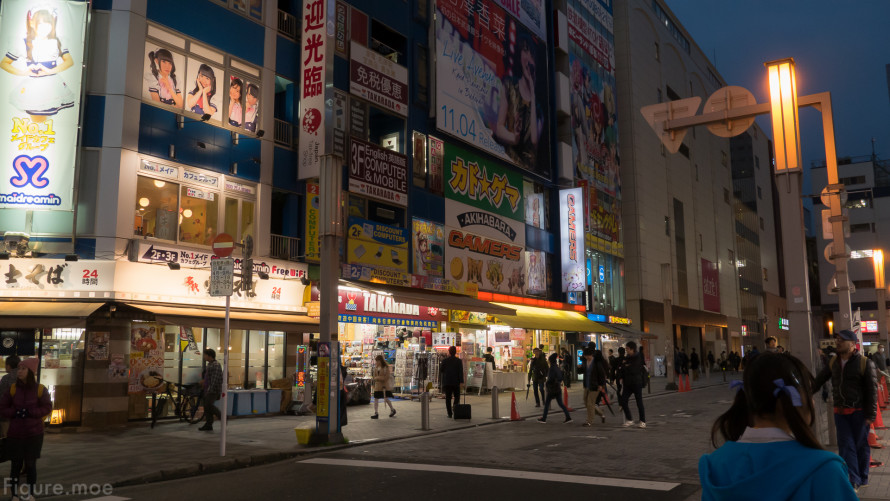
299 0 333 179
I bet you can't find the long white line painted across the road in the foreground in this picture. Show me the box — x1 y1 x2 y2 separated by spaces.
300 458 680 491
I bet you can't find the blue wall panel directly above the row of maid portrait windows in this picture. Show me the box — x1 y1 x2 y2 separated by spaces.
147 0 262 66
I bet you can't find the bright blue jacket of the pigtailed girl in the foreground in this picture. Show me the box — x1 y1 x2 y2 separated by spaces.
698 440 859 501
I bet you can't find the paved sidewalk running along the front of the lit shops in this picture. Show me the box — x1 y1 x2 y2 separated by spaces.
31 375 723 486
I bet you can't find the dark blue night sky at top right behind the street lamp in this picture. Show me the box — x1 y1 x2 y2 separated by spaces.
665 0 890 193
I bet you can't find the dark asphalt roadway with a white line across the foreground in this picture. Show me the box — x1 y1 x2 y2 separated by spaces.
33 378 890 501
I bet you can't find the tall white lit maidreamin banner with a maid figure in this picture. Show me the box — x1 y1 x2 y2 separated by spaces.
0 0 87 211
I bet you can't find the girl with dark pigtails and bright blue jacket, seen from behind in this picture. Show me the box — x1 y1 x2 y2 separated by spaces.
698 353 857 501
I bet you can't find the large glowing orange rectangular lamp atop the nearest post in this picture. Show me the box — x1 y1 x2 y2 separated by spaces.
764 58 801 172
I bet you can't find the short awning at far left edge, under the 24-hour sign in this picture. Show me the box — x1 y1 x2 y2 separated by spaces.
0 301 105 329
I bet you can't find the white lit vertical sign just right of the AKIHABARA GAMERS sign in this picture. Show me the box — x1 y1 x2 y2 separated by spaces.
559 188 587 292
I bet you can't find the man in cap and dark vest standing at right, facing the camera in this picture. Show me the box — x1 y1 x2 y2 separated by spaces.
814 329 878 489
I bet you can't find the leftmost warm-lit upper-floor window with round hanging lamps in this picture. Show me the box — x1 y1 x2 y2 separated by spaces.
133 176 179 241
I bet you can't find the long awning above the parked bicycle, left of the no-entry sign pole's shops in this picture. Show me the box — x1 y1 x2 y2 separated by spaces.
126 303 318 332
